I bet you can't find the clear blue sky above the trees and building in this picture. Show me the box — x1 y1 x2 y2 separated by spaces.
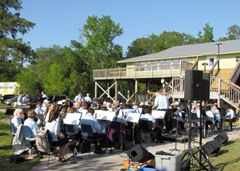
20 0 240 55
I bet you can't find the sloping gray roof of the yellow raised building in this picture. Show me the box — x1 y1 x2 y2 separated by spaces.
118 39 240 63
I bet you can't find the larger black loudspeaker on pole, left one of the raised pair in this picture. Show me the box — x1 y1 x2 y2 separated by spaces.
184 70 203 100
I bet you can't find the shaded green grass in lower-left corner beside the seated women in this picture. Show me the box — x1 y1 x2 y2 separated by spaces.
0 112 38 171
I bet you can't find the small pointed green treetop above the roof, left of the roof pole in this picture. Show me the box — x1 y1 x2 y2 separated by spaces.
198 23 214 43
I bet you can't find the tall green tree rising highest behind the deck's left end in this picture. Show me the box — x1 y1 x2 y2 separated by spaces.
82 16 123 69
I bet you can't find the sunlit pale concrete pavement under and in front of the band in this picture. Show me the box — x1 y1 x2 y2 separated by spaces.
31 124 240 171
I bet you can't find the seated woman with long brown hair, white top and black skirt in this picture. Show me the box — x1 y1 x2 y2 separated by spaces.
45 103 68 162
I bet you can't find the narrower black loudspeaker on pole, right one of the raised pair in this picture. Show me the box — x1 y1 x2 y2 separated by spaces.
201 73 210 101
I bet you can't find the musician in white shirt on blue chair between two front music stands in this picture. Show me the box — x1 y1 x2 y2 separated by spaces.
81 108 106 153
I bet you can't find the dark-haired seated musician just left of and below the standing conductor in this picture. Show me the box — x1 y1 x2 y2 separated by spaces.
139 106 164 143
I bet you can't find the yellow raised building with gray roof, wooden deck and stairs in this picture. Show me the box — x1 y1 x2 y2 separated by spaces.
93 40 240 107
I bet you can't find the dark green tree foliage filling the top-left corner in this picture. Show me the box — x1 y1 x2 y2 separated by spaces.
0 0 35 79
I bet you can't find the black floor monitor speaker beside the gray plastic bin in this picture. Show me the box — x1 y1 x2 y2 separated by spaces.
128 144 155 163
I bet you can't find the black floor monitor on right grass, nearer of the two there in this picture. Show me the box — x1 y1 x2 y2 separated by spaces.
203 140 221 156
